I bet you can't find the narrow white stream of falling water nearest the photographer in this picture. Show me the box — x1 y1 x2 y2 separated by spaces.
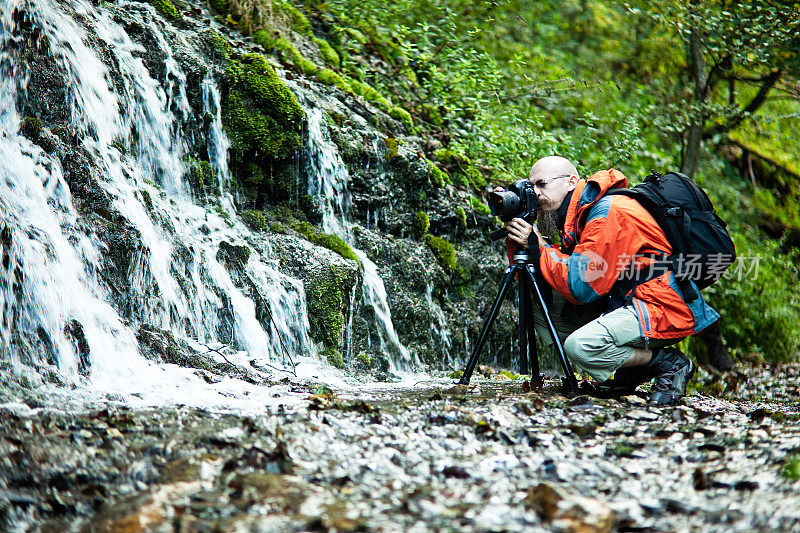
306 107 417 370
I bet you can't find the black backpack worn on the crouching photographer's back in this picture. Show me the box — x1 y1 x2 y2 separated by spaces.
606 171 736 302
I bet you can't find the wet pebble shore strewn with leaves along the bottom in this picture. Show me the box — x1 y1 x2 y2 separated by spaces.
0 365 800 532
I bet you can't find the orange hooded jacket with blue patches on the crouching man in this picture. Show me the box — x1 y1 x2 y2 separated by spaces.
539 169 719 339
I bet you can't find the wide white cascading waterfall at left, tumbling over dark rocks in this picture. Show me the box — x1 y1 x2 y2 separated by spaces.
0 0 334 403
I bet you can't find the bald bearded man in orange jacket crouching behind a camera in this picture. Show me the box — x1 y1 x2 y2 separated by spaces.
506 156 719 405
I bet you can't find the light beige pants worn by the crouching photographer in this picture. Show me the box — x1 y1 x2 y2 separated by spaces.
534 291 682 381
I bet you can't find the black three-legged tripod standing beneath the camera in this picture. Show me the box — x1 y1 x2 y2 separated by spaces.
458 247 578 395
